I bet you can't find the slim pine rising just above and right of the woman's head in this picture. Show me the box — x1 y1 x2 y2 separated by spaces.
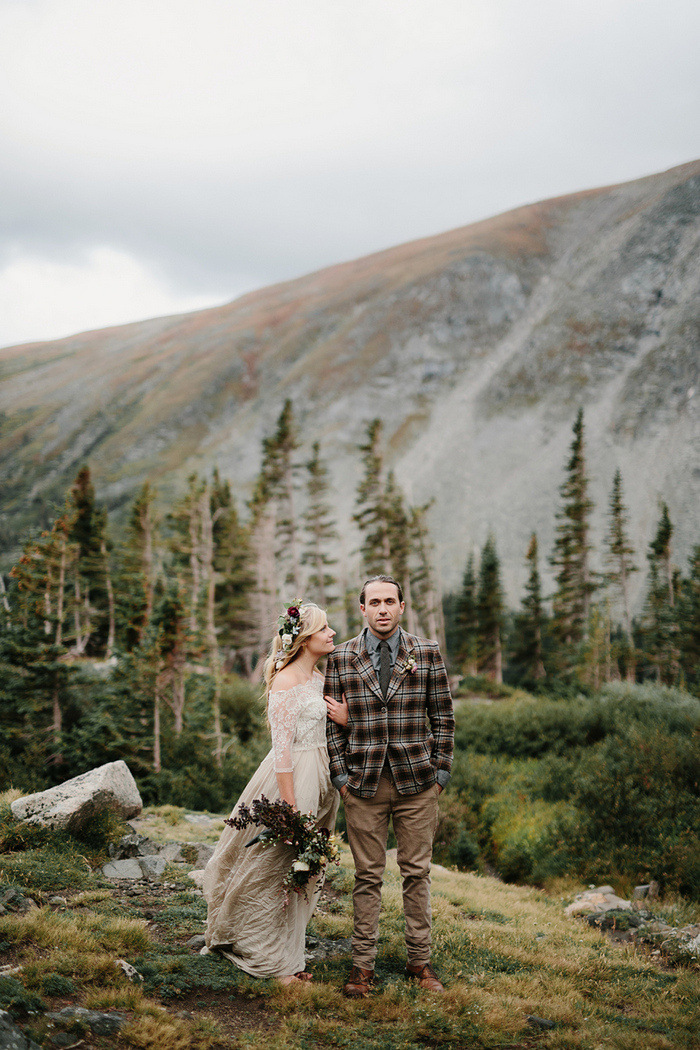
301 441 338 609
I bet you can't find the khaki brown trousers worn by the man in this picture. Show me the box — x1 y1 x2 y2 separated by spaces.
344 775 440 970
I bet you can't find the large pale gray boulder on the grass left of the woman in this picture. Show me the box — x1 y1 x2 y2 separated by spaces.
12 761 143 831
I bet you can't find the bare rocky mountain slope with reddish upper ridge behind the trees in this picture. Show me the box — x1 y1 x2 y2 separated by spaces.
0 154 700 603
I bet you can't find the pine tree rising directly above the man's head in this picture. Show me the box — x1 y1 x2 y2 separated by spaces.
353 419 391 575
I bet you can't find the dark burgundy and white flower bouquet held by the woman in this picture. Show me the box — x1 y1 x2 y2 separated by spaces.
226 795 340 907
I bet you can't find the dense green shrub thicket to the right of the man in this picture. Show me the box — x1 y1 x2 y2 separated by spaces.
443 685 700 900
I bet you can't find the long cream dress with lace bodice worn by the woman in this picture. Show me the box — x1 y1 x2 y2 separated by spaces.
203 673 338 978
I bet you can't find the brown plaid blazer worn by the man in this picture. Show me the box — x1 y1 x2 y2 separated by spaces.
324 628 454 798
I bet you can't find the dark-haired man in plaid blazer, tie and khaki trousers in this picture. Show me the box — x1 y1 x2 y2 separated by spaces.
324 575 454 999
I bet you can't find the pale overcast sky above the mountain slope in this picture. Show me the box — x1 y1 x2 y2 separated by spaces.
0 0 700 347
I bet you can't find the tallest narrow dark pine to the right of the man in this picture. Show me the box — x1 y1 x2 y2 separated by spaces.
550 410 595 669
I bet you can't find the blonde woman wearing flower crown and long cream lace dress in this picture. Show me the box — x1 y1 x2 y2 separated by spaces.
203 603 347 984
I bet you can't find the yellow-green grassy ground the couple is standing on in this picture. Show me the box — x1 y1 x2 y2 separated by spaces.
0 797 700 1050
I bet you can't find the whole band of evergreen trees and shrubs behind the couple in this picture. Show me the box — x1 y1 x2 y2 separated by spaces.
0 401 700 898
